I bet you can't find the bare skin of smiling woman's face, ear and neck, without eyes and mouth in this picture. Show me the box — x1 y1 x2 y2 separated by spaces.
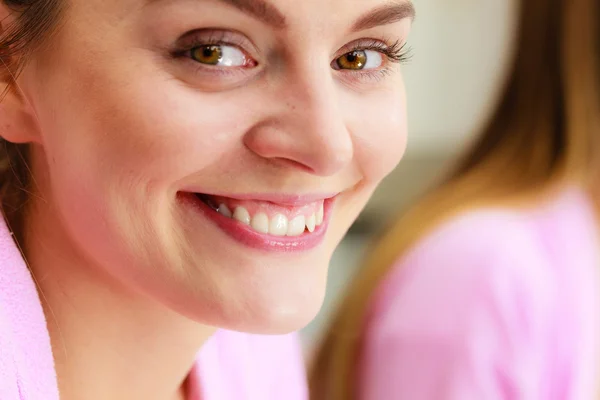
0 0 411 399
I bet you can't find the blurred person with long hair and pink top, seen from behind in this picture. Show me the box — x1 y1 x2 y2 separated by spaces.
311 0 600 400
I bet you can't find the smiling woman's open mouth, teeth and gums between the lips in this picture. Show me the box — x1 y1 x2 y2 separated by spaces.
194 193 327 238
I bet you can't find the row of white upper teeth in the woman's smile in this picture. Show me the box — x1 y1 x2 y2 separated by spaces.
217 204 323 236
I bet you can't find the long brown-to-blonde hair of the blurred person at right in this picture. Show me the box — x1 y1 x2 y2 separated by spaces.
309 0 600 400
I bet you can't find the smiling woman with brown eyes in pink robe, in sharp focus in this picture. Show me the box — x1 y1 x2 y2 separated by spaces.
0 0 414 400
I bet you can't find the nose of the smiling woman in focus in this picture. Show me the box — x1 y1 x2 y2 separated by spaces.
245 75 354 176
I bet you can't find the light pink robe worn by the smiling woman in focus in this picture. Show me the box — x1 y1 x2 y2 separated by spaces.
0 218 308 400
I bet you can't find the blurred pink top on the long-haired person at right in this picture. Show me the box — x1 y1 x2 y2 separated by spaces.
359 190 600 400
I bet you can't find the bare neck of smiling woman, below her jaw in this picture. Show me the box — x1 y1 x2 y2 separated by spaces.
25 202 214 400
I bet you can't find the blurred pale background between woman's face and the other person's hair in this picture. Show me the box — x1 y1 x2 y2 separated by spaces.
302 0 517 357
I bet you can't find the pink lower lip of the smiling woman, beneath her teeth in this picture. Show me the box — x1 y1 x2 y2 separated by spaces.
180 193 335 252
